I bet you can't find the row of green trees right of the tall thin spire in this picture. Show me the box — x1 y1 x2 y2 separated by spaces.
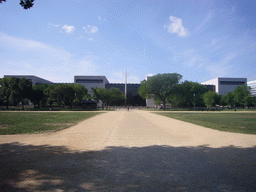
138 73 256 109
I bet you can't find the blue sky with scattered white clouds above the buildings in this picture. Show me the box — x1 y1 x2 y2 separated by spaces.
0 0 256 83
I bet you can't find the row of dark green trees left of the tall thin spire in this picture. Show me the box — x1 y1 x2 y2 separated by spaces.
0 77 124 110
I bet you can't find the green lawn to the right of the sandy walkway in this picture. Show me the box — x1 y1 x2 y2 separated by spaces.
155 112 256 134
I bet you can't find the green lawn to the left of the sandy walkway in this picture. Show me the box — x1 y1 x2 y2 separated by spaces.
0 112 102 135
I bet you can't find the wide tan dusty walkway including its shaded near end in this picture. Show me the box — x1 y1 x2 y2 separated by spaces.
0 110 256 191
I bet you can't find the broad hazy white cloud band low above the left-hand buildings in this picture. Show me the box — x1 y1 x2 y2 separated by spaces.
0 32 98 82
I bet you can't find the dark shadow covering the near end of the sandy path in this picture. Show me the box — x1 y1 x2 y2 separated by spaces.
0 143 256 191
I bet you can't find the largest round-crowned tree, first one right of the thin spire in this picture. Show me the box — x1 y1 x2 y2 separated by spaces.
142 73 182 110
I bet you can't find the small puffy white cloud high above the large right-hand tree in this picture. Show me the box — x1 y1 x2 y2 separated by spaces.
164 16 189 37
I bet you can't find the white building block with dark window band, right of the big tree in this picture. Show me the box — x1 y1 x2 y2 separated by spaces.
201 77 247 95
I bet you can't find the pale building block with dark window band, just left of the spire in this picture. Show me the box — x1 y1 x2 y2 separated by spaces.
74 76 109 95
